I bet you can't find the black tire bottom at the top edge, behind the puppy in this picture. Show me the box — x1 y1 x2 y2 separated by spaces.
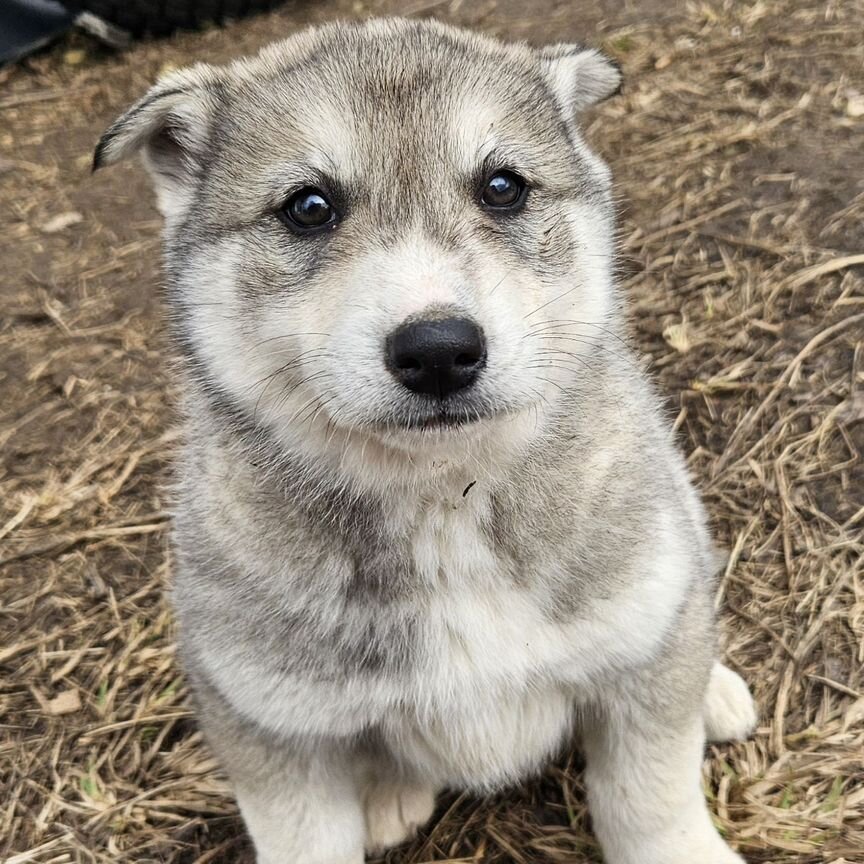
64 0 275 36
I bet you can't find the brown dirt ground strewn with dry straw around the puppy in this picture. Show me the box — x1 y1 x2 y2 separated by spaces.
0 0 864 864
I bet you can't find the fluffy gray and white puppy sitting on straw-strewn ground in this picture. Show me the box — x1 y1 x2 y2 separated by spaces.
96 20 755 864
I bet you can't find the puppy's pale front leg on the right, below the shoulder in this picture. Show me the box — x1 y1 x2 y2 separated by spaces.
584 660 743 864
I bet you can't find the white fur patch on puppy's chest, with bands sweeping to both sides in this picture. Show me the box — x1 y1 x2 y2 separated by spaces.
201 490 689 785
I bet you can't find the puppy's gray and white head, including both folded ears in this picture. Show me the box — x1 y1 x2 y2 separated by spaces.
97 21 618 452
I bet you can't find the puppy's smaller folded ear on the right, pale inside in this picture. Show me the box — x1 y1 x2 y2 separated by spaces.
539 44 621 117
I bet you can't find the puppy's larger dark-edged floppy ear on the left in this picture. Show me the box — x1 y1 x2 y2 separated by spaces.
93 66 217 217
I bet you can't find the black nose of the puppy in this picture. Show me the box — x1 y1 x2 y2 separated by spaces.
387 318 486 399
